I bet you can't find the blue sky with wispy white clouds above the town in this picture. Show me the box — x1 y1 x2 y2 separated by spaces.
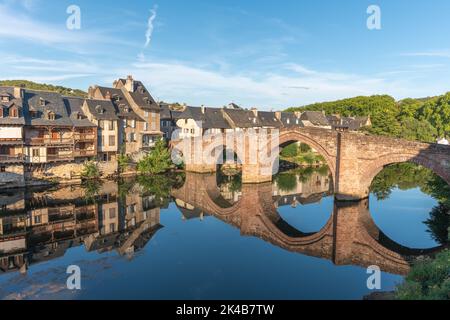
0 0 450 110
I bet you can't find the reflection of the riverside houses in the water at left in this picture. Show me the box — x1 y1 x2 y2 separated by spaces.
0 182 162 273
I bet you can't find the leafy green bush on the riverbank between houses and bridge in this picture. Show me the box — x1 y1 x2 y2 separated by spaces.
137 139 172 174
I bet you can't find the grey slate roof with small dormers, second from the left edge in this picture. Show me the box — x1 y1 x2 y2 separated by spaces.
23 89 73 127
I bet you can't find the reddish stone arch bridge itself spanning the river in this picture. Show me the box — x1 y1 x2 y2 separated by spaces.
171 128 450 200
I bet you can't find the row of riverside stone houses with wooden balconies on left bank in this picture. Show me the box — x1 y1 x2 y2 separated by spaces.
0 76 162 184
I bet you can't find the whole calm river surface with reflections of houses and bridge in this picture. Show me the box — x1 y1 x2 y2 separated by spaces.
0 168 447 299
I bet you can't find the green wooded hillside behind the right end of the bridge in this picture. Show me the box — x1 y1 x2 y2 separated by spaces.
287 92 450 142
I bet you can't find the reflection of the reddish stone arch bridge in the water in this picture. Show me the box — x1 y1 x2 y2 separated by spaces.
172 173 442 275
